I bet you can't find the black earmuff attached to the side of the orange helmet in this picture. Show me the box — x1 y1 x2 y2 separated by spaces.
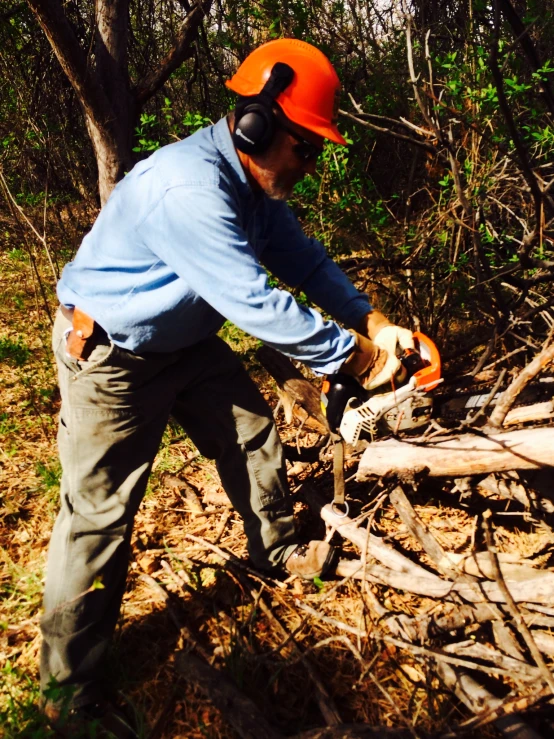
232 62 294 154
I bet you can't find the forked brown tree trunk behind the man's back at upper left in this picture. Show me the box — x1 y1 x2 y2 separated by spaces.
27 0 211 205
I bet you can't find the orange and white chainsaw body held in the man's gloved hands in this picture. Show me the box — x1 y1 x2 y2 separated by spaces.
321 331 441 446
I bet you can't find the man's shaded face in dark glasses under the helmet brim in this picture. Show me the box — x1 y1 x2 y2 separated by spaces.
250 120 324 200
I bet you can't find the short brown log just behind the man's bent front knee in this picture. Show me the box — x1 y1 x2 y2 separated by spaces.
256 346 329 434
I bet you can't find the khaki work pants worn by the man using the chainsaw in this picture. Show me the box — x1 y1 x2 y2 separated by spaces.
41 312 296 706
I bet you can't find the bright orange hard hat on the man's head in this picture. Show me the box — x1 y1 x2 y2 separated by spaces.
225 38 346 144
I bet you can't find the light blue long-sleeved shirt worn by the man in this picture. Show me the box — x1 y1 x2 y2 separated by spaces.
58 119 371 374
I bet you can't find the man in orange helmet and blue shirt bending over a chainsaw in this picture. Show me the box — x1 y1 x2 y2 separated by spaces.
41 39 411 736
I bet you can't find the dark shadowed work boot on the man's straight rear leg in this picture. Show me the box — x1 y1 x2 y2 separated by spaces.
43 702 139 739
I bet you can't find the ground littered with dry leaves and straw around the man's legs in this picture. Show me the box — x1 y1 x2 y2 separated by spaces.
0 244 552 739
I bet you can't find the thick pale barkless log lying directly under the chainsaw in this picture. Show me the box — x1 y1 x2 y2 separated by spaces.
356 427 554 481
